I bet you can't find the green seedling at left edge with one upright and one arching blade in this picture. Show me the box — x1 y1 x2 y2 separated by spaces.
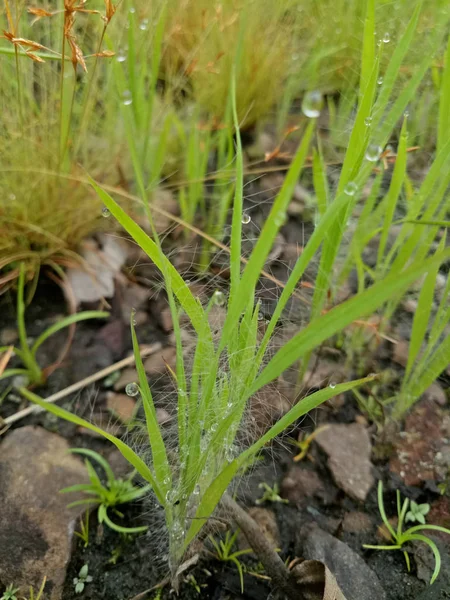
0 264 109 385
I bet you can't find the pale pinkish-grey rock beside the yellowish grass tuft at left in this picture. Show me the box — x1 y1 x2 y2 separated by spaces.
67 235 126 305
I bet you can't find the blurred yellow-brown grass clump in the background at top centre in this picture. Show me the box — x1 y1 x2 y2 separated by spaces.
161 0 293 127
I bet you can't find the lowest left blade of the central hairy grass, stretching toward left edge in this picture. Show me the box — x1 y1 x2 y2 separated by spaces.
19 388 166 506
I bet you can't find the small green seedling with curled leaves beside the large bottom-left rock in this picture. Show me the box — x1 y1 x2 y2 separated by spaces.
61 448 151 543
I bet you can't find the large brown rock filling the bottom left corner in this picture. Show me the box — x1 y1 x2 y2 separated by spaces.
0 426 89 600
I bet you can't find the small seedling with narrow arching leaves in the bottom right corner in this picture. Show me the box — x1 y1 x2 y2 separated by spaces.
363 481 450 585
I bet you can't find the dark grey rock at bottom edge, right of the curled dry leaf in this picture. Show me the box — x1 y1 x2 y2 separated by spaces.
296 525 386 600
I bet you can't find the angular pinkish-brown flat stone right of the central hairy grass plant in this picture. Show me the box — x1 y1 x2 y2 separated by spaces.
315 423 374 502
